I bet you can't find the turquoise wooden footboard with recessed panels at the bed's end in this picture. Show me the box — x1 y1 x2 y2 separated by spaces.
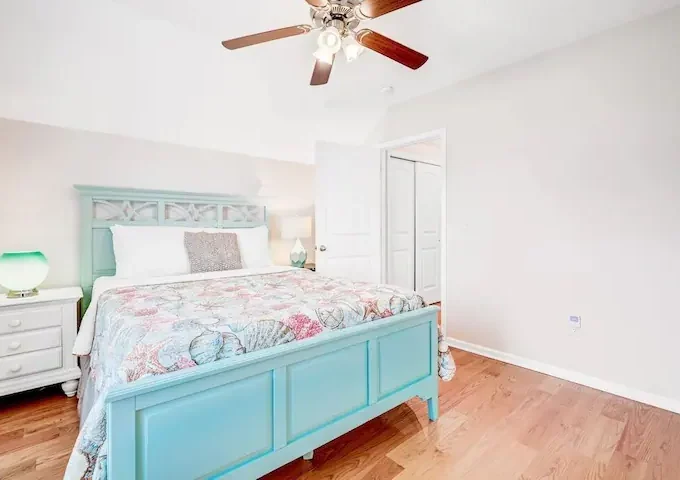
106 307 439 480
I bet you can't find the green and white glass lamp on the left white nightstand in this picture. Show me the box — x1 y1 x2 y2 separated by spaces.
0 252 50 298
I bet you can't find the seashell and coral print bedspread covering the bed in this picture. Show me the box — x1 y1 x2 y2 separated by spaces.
65 269 455 480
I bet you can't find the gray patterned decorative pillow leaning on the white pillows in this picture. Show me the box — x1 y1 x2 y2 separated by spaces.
184 232 243 273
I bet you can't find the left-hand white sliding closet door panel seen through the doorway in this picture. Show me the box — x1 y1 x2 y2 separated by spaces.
386 157 416 290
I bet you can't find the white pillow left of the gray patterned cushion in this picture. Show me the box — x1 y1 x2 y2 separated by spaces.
111 225 190 278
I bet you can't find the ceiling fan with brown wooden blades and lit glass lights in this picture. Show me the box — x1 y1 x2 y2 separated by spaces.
222 0 428 85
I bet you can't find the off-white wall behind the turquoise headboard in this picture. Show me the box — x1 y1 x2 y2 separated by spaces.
0 119 315 286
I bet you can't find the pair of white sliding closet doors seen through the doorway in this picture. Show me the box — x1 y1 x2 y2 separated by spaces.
386 157 443 304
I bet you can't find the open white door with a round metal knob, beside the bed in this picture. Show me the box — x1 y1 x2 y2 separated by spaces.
315 142 382 283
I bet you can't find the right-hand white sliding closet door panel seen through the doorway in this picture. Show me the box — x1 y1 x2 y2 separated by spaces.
415 162 443 304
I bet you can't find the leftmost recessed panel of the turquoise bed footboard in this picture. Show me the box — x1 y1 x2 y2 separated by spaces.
136 372 274 479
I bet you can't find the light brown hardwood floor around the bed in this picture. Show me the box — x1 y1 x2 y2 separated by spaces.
0 350 680 480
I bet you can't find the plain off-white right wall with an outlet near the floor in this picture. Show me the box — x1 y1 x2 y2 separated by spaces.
384 9 680 404
